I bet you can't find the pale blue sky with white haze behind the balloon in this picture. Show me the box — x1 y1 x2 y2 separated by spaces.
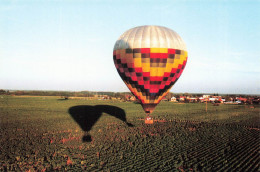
0 0 260 94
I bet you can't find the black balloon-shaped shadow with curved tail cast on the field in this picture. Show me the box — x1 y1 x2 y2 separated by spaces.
68 105 133 142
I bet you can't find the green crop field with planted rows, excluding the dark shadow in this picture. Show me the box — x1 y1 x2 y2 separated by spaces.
0 96 260 171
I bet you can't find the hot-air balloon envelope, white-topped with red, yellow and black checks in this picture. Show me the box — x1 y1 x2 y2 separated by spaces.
113 26 188 114
